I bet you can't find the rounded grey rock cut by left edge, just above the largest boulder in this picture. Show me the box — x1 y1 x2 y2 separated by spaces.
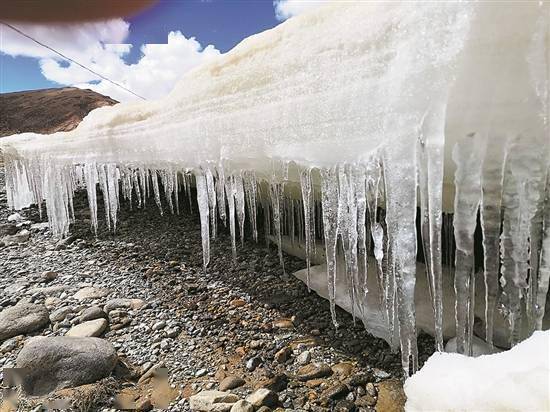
0 303 50 342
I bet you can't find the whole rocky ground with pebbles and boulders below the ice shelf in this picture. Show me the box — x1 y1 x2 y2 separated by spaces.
0 169 433 412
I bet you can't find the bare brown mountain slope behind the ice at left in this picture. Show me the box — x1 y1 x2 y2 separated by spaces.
0 87 118 137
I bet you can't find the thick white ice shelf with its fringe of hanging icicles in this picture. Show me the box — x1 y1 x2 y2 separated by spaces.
0 1 550 375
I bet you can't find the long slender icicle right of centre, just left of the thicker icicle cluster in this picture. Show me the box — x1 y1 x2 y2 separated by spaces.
321 168 338 328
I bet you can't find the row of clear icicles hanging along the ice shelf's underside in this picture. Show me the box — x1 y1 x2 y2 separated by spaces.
6 150 550 373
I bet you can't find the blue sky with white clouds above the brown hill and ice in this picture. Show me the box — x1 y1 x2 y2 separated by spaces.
0 0 315 100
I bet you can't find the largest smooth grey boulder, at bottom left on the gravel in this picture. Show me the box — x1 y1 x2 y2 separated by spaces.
16 336 117 396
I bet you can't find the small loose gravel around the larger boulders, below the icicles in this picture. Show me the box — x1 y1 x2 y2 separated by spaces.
0 170 433 411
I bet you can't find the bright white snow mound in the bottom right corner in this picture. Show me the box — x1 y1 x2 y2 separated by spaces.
405 331 550 412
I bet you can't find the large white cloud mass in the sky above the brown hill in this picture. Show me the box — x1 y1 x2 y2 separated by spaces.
0 19 220 101
